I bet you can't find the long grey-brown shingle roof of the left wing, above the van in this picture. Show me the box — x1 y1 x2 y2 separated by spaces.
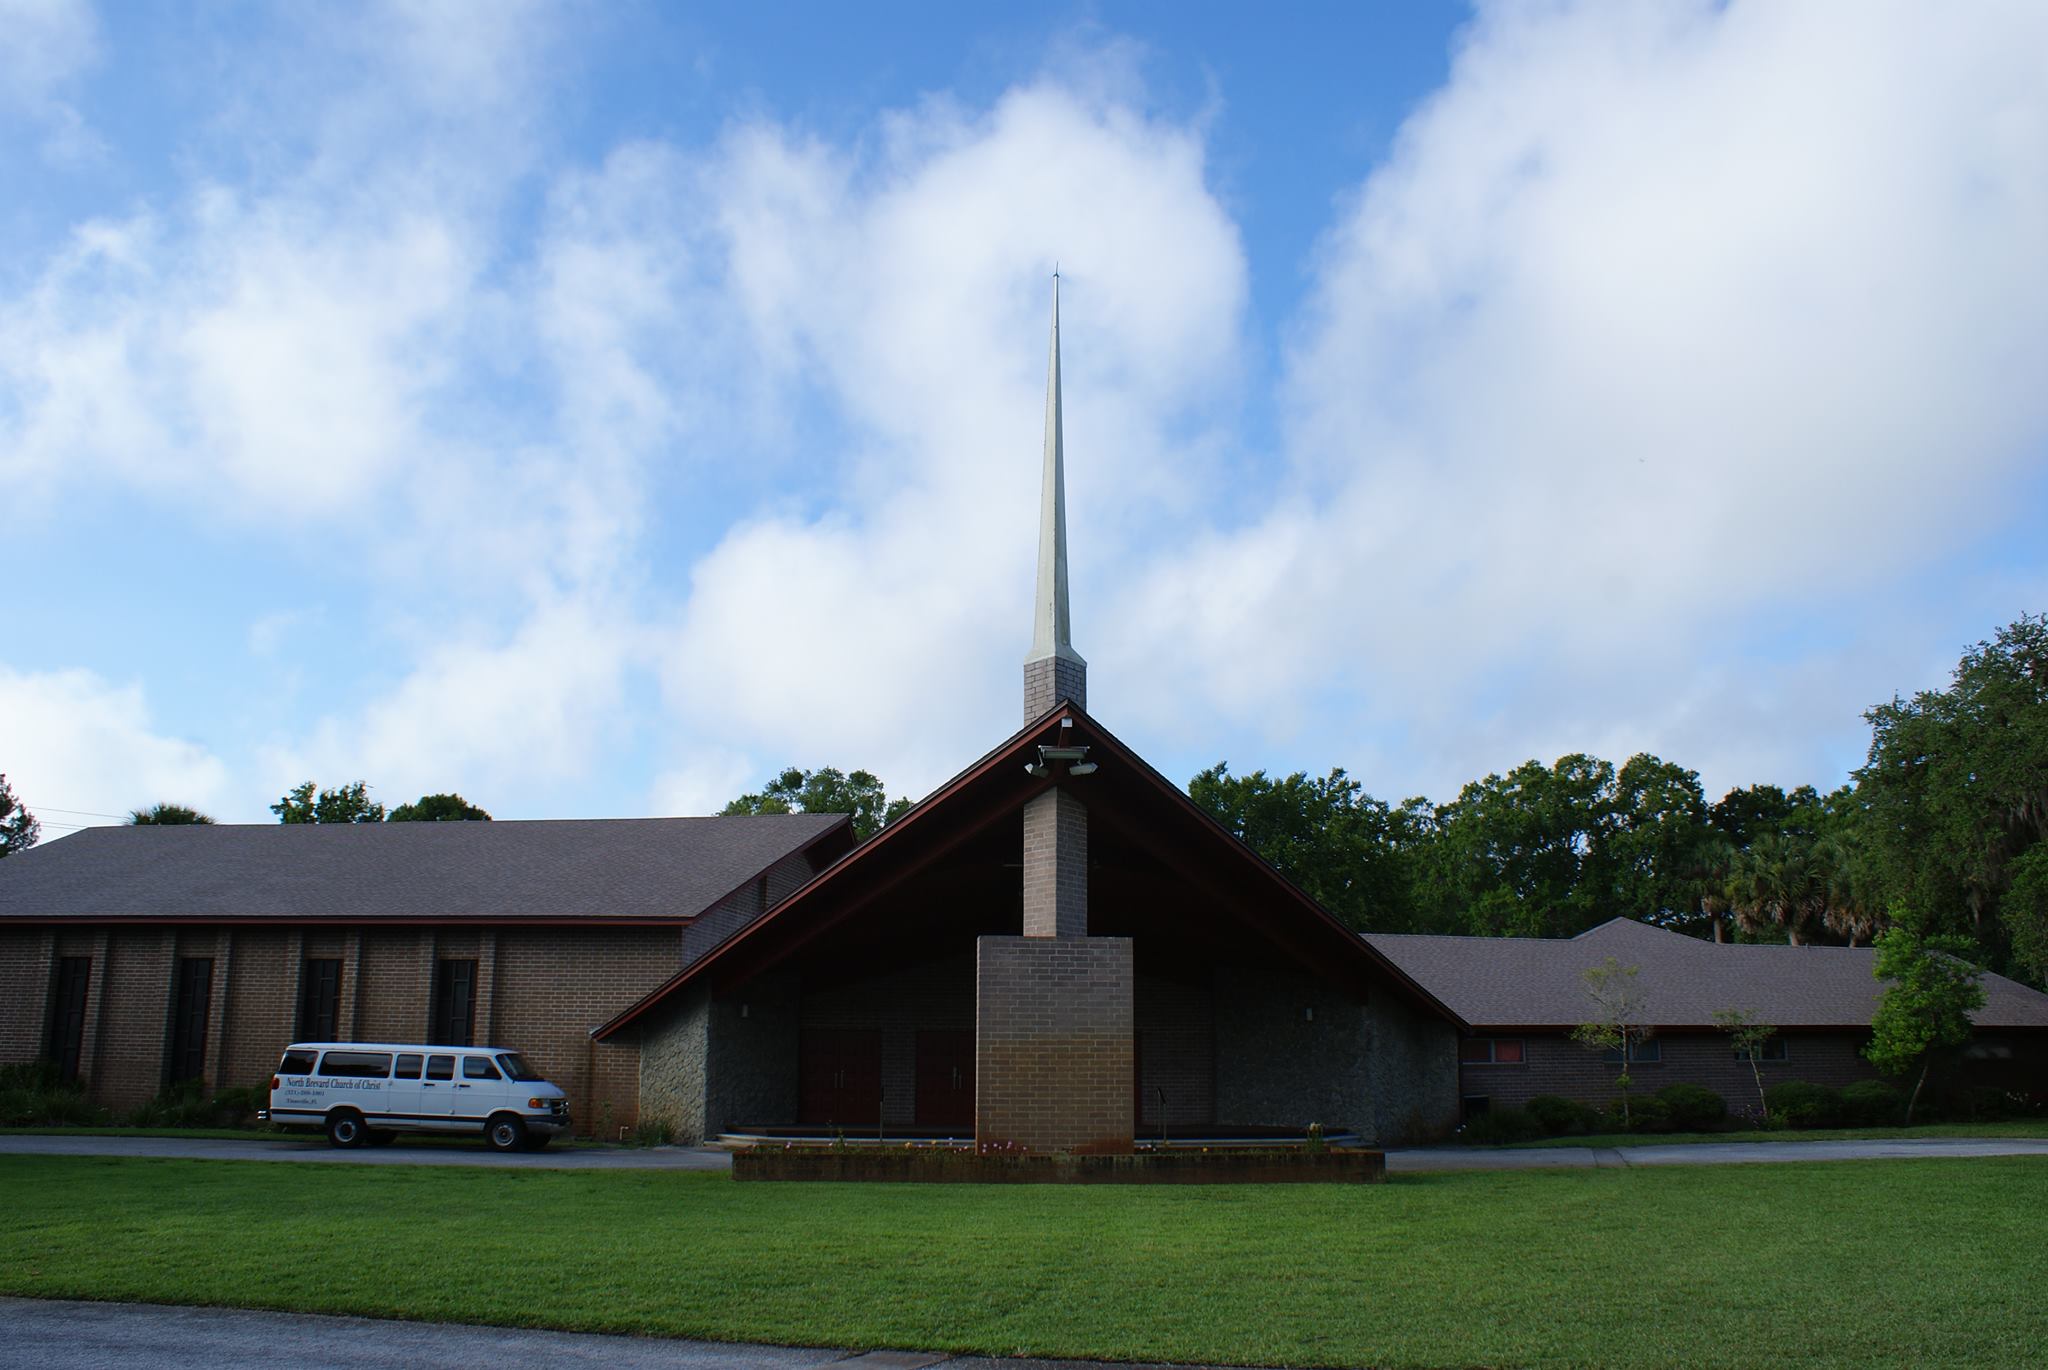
0 813 846 922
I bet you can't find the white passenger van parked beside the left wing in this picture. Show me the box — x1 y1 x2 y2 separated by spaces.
256 1042 569 1151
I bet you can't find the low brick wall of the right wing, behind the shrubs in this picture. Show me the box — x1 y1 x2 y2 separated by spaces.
1458 1030 1876 1112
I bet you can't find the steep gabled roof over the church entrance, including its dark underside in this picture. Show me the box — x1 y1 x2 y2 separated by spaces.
592 702 1458 1040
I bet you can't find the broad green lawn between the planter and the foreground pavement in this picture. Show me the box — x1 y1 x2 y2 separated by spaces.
0 1157 2048 1366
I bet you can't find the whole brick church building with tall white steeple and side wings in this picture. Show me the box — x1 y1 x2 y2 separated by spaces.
0 283 2048 1153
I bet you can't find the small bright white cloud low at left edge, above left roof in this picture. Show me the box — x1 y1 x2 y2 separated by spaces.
0 666 231 823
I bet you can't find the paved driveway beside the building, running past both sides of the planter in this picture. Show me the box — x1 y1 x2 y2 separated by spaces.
0 1134 2048 1175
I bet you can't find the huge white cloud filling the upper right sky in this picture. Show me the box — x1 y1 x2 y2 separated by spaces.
1114 2 2048 788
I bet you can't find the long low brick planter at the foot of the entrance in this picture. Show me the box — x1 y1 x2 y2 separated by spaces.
733 1147 1386 1184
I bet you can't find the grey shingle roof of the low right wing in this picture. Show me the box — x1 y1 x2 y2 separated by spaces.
1366 917 2048 1028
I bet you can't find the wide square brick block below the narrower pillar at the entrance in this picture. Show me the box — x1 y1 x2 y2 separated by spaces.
975 933 1135 1153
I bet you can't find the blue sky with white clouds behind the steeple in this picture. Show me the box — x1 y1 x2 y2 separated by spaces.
0 0 2048 836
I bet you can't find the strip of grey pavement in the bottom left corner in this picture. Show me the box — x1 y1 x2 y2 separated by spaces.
0 1298 1236 1370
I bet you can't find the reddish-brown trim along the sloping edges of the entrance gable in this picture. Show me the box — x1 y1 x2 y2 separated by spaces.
590 700 1466 1040
